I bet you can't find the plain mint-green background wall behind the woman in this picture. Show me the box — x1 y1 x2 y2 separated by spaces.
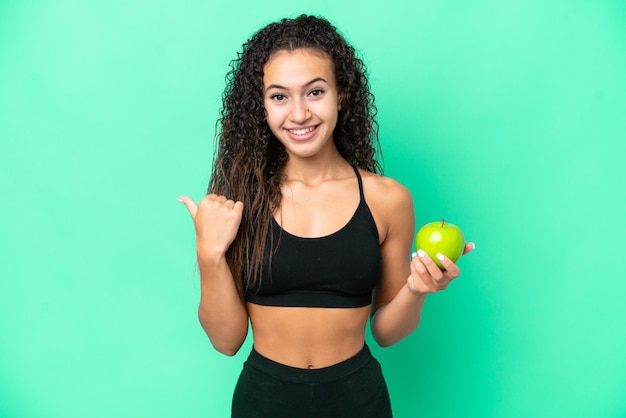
0 0 626 418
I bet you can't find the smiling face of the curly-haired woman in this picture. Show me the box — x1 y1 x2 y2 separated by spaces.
263 49 341 158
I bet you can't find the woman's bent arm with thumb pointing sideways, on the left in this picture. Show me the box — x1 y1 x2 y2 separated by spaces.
179 194 248 356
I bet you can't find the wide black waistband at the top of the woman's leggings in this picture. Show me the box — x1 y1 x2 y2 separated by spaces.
245 344 374 383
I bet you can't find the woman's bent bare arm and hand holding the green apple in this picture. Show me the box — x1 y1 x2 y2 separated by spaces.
371 179 474 347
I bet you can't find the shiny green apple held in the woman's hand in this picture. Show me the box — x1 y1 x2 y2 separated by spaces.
415 219 465 269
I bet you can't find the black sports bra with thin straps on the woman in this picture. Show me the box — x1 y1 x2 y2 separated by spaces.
245 167 381 308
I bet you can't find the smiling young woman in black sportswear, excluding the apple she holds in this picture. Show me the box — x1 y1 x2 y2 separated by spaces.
180 16 473 418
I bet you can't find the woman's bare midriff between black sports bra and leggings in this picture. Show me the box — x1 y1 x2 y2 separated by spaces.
248 303 370 369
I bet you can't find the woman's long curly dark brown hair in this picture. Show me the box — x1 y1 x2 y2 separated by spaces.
208 15 382 295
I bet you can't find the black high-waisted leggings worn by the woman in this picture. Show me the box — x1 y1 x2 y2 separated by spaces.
232 345 392 418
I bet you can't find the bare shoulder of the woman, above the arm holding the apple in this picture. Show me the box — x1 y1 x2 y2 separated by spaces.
360 171 414 241
